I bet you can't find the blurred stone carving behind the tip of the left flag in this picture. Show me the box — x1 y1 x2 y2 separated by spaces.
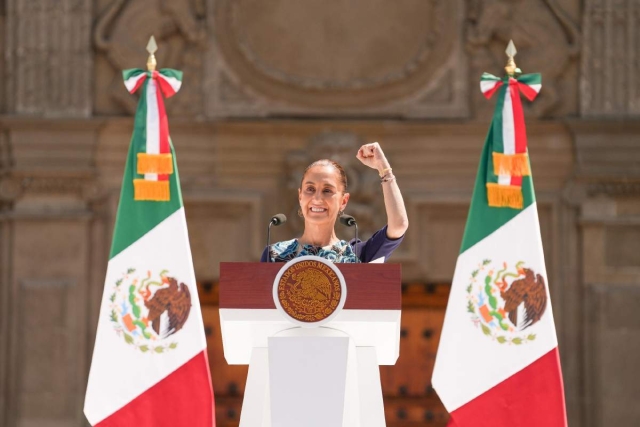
94 0 206 116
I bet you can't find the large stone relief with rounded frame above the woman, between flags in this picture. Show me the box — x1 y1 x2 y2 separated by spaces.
206 0 467 117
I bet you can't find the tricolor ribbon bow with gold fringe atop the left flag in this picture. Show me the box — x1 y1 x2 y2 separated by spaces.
122 68 182 201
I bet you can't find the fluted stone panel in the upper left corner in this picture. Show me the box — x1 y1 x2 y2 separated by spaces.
5 0 93 117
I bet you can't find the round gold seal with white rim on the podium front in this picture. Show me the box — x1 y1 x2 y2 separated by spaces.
273 256 347 326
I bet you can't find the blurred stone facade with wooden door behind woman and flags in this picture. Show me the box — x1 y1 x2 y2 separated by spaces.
0 0 640 427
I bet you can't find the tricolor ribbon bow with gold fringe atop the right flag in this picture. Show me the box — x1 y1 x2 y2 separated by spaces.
480 73 542 209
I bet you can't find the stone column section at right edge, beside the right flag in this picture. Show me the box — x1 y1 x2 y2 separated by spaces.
565 121 640 427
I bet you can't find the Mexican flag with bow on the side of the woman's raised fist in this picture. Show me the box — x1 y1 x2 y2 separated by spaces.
432 74 567 427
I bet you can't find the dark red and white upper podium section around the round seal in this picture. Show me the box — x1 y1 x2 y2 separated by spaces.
220 263 402 365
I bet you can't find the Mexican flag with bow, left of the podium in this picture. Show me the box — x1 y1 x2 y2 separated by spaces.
84 69 215 427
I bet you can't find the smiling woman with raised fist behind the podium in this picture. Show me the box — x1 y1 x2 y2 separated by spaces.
261 142 409 263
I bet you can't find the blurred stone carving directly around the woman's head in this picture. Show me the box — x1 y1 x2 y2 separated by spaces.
286 132 386 239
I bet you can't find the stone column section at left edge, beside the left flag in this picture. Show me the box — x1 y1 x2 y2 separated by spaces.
0 120 107 427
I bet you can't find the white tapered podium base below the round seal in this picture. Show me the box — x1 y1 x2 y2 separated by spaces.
240 328 385 427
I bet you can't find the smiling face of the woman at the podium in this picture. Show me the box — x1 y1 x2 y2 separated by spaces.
298 166 349 227
